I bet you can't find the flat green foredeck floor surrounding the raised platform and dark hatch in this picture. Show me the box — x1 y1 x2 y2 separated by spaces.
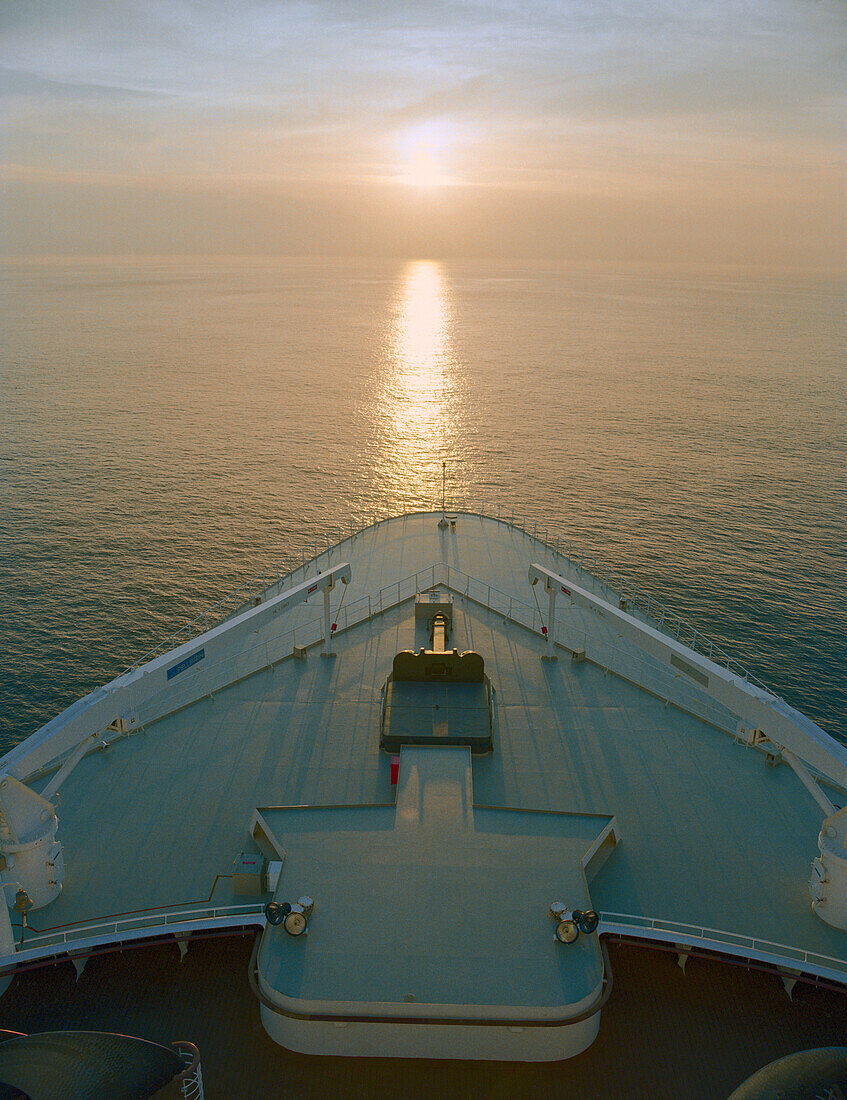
1 515 847 977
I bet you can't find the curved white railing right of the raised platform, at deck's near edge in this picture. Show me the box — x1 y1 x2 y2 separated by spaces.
598 913 847 982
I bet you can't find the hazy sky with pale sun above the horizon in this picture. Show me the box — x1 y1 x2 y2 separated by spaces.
0 0 847 268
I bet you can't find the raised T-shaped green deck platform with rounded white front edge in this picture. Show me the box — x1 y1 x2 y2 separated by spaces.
257 747 614 1060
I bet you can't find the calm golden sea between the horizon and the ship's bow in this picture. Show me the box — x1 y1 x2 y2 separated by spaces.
0 260 847 749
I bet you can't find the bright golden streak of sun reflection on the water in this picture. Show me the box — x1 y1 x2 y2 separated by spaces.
384 261 454 494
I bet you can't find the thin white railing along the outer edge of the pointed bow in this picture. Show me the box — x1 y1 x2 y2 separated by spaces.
125 503 771 691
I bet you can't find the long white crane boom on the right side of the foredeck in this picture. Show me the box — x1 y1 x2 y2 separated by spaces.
529 563 847 787
